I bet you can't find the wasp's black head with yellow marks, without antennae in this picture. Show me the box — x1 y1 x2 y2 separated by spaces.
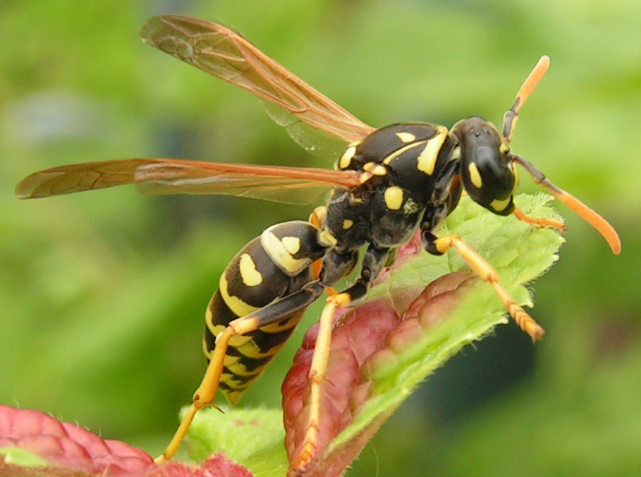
451 117 517 215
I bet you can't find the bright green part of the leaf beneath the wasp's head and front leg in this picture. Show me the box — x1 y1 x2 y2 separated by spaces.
327 194 564 458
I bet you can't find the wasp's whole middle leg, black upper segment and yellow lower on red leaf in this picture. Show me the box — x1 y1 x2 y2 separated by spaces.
290 245 392 470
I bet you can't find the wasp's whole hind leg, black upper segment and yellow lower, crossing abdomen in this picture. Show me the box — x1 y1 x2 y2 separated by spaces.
156 281 325 463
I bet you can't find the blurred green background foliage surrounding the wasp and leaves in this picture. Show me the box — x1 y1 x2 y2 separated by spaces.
0 0 641 476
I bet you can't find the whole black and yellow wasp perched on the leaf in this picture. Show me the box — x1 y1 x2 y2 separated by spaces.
16 15 621 469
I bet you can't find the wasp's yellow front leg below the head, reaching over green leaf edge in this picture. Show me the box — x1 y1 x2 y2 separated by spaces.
423 232 545 342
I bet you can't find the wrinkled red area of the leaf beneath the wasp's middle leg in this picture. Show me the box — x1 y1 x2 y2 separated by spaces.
282 273 474 476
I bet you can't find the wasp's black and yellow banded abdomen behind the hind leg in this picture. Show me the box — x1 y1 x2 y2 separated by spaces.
204 221 326 404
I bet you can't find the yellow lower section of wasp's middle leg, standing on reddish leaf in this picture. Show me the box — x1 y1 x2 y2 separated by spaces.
291 293 351 469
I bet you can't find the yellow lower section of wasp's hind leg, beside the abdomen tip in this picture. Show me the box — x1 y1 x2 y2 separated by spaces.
156 317 259 464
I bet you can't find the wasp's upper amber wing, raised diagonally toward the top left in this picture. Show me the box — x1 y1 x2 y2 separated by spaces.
140 15 374 158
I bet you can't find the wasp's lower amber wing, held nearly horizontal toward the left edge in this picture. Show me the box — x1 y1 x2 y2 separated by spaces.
16 159 359 204
